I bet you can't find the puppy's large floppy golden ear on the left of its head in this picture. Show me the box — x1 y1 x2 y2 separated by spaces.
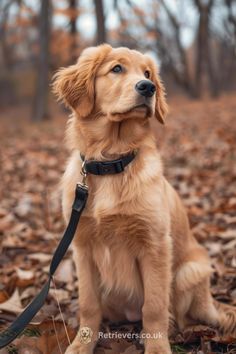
53 44 111 117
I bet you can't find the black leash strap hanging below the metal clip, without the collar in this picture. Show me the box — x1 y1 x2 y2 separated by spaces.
0 184 88 349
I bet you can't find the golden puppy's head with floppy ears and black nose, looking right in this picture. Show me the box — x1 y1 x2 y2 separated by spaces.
53 44 167 123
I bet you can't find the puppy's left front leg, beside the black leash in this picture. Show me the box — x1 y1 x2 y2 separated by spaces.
66 247 102 354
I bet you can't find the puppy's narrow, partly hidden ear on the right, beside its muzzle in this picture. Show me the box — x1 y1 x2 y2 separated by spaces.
154 74 168 124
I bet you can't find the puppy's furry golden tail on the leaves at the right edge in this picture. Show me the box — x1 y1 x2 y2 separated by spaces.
214 300 236 337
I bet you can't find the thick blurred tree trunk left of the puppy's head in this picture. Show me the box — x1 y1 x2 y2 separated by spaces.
32 0 51 121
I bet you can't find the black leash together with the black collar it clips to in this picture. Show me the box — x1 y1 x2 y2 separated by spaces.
0 151 137 349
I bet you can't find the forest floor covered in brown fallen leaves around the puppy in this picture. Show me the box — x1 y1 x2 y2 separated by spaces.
0 96 236 354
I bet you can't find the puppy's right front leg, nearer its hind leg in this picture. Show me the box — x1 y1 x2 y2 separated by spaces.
139 239 171 354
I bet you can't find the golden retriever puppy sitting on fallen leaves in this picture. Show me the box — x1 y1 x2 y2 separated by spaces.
54 44 236 354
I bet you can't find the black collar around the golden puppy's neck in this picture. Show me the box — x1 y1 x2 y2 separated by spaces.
80 151 137 176
